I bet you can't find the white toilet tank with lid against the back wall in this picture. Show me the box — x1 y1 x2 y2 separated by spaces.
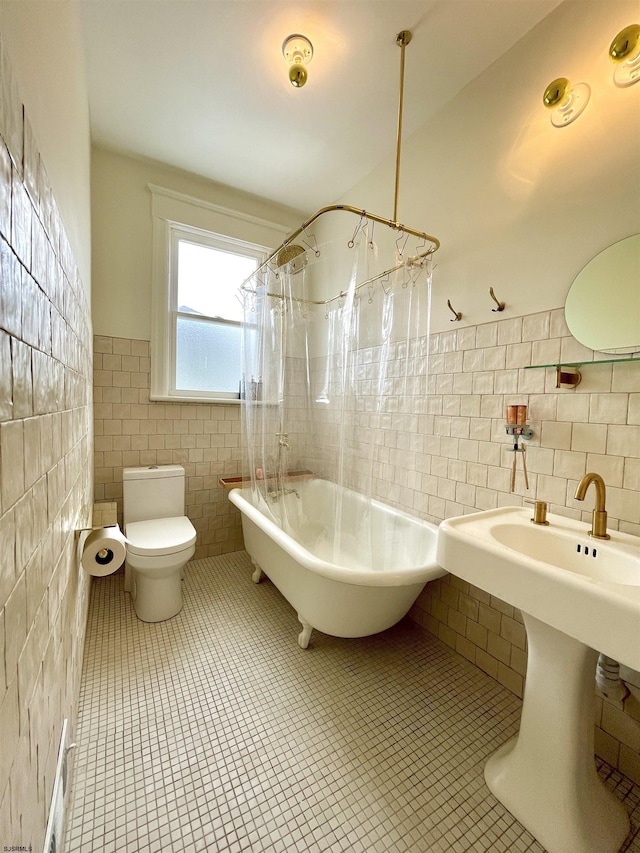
122 465 185 524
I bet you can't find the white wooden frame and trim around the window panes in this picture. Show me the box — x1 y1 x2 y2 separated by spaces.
149 184 290 404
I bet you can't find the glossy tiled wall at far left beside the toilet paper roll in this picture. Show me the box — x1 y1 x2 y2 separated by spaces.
0 45 93 850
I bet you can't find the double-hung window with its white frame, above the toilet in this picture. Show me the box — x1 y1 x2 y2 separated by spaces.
150 187 288 403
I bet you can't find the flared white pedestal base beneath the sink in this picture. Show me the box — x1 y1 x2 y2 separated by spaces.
484 613 629 853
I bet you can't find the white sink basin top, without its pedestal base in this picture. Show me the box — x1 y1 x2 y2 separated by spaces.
438 507 640 670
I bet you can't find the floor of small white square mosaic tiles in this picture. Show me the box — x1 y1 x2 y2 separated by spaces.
65 552 640 853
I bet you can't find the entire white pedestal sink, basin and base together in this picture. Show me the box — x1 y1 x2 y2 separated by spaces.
438 507 640 853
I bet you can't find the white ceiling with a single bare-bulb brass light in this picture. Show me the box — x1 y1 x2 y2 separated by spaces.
81 0 560 213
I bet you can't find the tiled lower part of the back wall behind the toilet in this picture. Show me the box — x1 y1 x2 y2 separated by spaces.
93 335 242 559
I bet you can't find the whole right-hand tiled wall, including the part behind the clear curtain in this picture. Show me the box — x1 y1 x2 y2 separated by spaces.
276 309 640 782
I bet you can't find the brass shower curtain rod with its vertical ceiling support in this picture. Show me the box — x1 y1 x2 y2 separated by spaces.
240 30 440 298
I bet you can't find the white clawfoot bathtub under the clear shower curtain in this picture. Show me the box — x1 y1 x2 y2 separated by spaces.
229 479 446 649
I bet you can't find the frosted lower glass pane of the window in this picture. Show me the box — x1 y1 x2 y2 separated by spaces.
176 317 242 394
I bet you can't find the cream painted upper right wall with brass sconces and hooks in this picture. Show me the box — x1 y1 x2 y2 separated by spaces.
341 0 640 331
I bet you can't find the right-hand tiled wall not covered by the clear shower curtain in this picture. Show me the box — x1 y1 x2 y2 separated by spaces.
410 322 640 782
